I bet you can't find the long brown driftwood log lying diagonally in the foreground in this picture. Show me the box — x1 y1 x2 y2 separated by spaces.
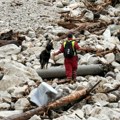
4 81 101 120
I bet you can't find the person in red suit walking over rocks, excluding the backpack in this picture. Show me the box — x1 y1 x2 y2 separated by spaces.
53 34 93 82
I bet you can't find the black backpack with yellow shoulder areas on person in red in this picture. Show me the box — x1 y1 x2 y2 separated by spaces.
64 41 75 58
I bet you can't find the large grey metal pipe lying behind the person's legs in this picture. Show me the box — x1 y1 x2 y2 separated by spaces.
37 64 104 79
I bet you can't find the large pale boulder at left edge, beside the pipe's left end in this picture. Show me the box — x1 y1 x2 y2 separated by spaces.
0 61 42 90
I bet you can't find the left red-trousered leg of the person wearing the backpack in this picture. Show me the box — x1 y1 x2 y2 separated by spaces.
64 59 72 80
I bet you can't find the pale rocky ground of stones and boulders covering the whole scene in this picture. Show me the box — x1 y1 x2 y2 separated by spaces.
0 0 120 120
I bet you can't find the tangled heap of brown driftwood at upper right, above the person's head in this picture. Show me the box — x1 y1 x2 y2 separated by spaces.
58 0 114 39
